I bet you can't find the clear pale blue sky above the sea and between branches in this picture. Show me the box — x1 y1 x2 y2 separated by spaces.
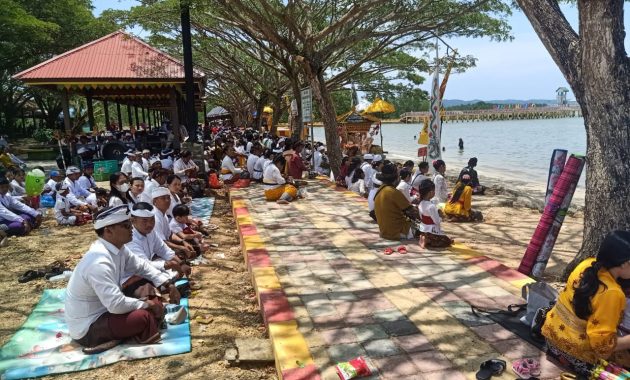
93 0 630 100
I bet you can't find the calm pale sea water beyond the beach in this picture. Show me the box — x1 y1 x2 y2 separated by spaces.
314 118 586 202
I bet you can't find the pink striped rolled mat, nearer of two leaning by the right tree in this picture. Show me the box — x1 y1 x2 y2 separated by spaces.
518 154 585 275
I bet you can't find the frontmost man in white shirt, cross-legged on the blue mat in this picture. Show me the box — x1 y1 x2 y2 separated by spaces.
65 205 178 354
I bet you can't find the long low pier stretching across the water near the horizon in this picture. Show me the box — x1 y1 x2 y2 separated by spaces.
400 106 582 123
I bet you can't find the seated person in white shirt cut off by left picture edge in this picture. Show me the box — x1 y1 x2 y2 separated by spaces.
0 177 42 236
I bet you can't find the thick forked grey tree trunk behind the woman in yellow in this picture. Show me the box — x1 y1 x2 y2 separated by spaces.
518 0 630 278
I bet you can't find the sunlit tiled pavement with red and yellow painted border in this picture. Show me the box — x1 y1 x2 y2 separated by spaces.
231 180 560 380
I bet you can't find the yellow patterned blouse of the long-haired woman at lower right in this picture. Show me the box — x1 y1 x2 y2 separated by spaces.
542 258 630 365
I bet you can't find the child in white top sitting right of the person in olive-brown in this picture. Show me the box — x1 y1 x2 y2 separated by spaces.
418 179 453 248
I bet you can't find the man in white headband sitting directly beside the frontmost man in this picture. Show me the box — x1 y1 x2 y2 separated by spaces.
122 202 190 288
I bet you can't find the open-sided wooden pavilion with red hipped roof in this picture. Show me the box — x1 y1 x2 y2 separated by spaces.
13 30 206 133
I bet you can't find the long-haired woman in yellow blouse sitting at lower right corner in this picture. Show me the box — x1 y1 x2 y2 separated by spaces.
542 231 630 375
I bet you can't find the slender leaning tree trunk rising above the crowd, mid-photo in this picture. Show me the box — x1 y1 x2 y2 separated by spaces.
306 67 341 175
